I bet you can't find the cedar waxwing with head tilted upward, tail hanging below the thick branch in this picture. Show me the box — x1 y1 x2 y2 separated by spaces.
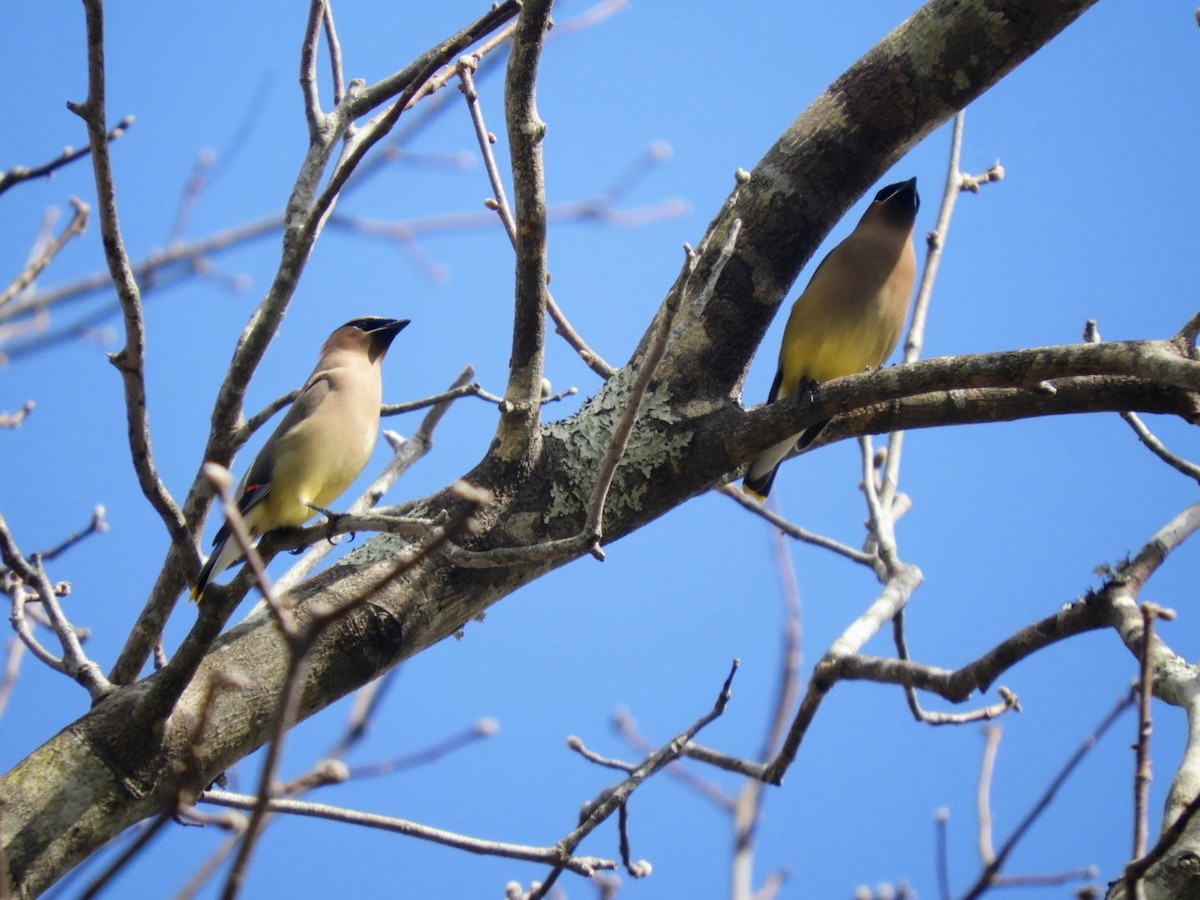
742 178 920 500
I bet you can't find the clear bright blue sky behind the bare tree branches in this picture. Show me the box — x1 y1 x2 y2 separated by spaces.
0 0 1200 898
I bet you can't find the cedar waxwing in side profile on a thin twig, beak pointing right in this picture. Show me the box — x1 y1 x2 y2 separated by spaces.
192 316 408 600
